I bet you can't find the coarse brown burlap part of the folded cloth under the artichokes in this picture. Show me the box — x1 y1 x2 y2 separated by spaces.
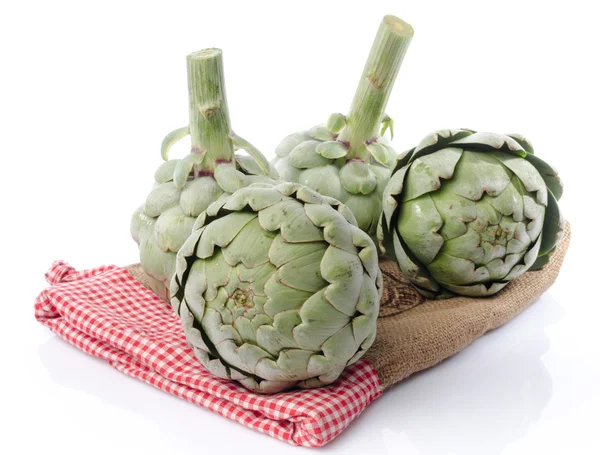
127 224 571 390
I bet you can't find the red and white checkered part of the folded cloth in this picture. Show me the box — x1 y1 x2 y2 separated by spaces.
35 261 382 447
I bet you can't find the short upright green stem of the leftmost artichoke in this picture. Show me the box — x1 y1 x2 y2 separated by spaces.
187 49 234 171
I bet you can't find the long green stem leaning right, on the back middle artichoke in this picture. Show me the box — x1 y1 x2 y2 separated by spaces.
338 16 413 161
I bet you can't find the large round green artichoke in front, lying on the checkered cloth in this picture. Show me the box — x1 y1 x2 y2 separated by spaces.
170 183 383 393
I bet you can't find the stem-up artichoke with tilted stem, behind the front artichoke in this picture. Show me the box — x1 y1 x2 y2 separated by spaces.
273 16 413 237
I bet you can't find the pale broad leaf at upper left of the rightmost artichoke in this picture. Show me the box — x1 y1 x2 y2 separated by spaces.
402 147 463 201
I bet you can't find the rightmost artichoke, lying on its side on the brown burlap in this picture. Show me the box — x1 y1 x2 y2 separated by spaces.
378 129 565 298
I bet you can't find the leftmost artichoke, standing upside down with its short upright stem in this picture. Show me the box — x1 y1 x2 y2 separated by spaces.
131 49 278 300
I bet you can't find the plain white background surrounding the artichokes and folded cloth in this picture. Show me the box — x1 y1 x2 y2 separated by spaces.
0 0 600 455
